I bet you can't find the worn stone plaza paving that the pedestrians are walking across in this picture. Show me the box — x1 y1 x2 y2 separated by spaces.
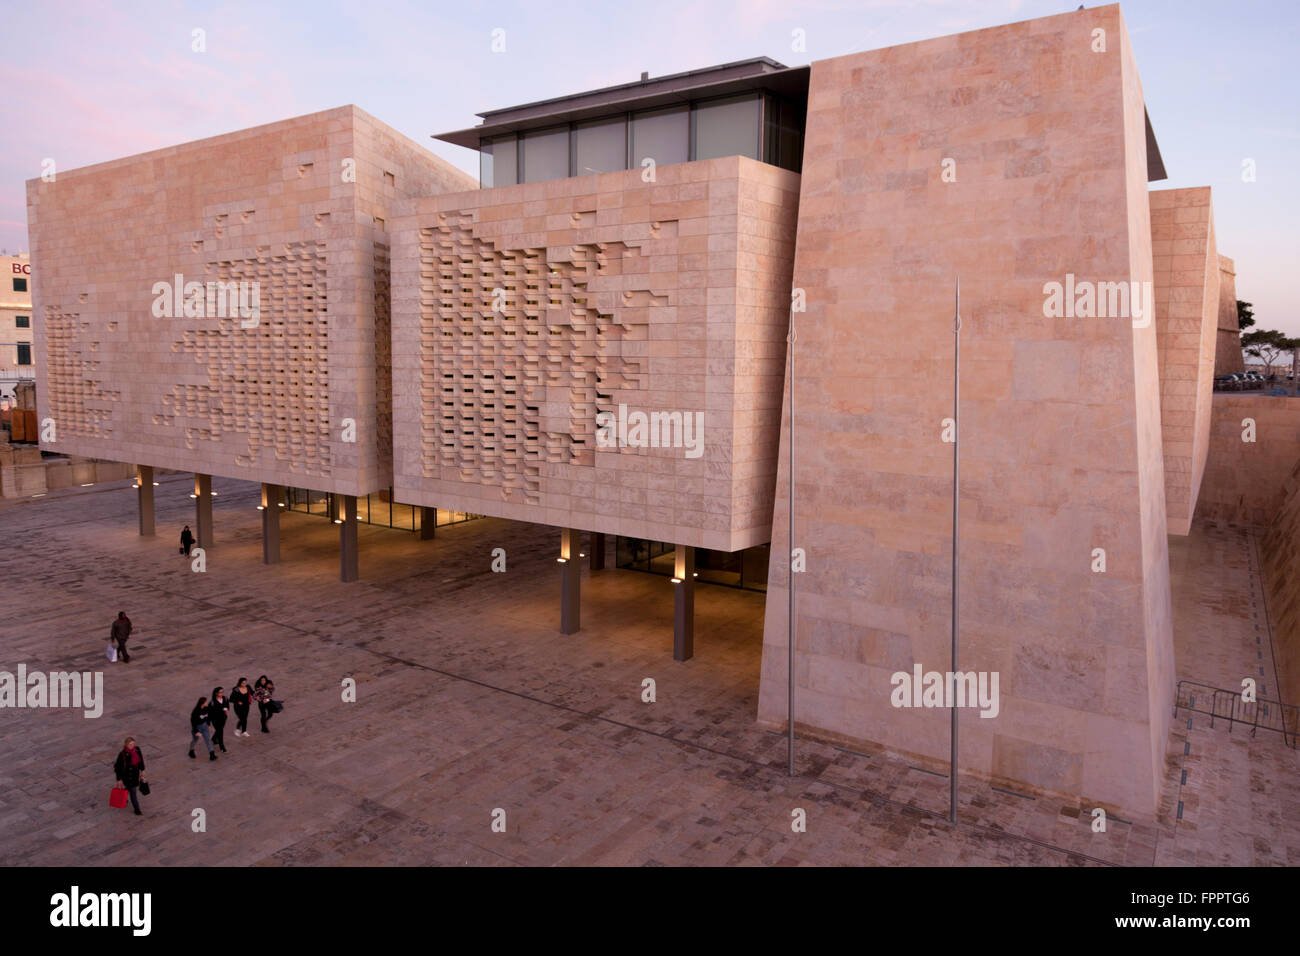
0 476 1300 865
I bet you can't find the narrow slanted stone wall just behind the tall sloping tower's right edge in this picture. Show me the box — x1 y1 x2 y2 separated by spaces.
1151 186 1222 535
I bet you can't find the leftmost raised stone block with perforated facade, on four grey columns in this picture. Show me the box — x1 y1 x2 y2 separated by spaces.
27 107 471 494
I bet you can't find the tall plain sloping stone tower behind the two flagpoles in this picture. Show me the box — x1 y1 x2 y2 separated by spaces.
759 7 1174 814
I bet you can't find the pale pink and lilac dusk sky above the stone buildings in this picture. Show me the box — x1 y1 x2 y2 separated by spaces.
0 0 1300 336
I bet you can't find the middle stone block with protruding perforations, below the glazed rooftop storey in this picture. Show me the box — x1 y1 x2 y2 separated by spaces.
393 157 798 551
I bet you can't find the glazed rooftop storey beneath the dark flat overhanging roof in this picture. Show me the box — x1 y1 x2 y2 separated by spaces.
478 91 807 189
